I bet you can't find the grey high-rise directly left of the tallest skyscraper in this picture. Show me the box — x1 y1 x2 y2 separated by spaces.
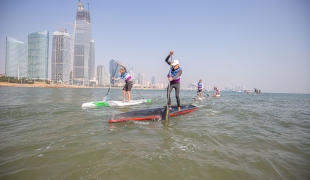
51 29 72 84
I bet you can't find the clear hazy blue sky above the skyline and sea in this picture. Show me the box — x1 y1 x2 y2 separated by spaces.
0 0 310 94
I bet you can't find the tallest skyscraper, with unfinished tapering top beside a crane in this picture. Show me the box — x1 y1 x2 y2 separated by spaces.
73 2 91 85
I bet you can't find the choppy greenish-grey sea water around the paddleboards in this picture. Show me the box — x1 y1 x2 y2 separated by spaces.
0 87 310 179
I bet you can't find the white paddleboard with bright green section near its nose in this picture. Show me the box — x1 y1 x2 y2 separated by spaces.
82 99 152 109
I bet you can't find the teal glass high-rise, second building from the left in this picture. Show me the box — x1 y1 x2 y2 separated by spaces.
27 31 49 79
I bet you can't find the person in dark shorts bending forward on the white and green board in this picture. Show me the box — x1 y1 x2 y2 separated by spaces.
112 62 133 102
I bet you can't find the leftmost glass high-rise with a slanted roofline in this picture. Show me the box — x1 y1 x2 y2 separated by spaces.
5 36 28 78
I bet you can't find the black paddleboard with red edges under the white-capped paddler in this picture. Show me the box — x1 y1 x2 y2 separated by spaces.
108 105 198 123
